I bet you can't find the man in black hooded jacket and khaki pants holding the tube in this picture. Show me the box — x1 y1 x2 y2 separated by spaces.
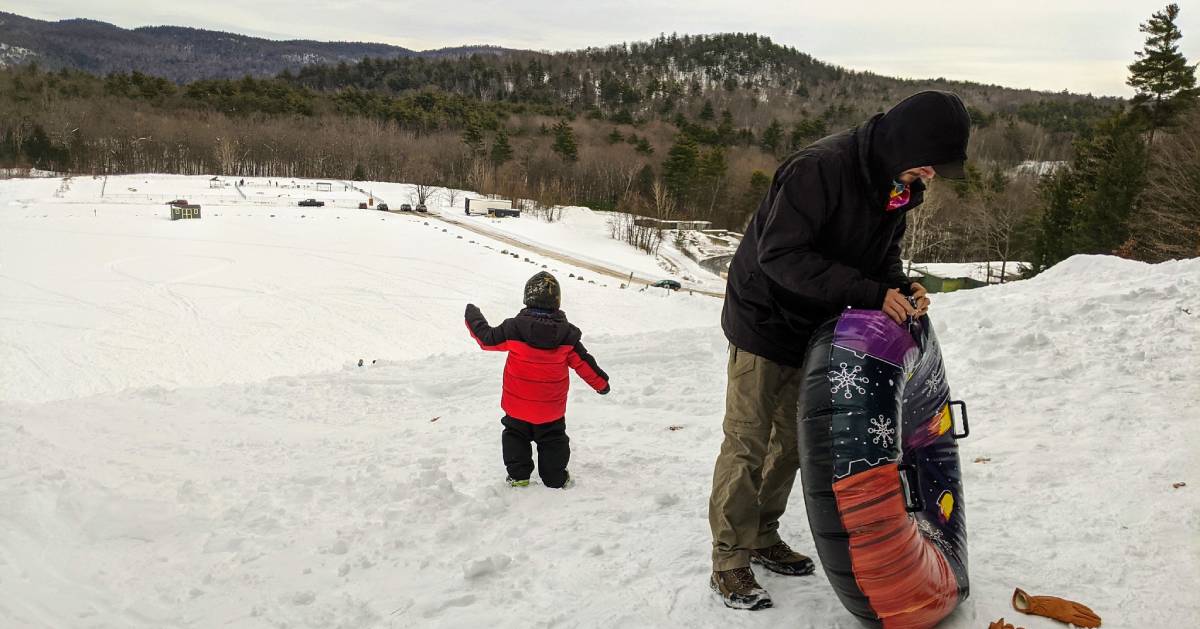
708 91 971 610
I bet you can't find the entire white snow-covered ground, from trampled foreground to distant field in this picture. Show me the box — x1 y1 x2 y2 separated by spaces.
0 174 1200 629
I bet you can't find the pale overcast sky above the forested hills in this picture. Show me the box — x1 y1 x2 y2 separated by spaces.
4 0 1200 96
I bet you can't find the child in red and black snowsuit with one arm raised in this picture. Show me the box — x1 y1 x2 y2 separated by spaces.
466 271 608 489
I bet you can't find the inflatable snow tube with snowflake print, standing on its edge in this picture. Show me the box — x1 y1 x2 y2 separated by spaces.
798 310 968 629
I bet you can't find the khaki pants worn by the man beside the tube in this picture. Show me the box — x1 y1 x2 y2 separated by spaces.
708 346 800 570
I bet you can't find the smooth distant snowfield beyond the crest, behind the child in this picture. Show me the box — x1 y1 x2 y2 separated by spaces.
0 175 720 401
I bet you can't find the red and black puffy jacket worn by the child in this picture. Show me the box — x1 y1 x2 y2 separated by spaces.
466 305 608 424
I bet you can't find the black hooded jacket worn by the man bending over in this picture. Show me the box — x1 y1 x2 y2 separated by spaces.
721 91 971 366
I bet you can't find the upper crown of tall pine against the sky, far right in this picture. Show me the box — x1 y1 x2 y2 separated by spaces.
1126 4 1200 142
